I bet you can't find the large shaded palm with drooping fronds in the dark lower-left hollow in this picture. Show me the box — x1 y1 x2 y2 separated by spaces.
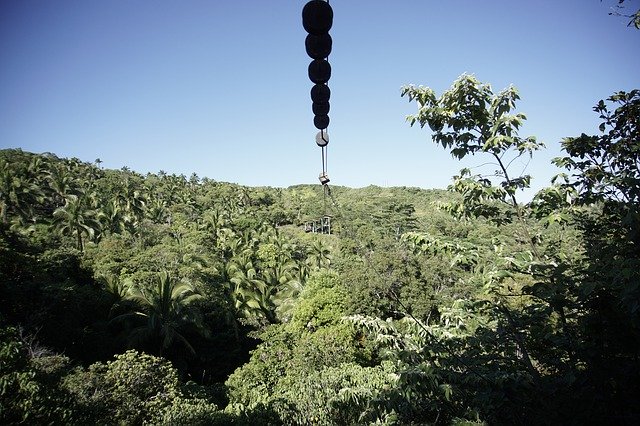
113 271 206 356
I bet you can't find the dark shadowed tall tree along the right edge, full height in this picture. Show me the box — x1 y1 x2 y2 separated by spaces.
555 90 640 406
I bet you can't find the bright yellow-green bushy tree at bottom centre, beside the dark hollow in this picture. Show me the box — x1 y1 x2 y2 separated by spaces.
226 272 384 424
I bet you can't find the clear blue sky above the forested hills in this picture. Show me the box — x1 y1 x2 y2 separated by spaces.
0 0 640 196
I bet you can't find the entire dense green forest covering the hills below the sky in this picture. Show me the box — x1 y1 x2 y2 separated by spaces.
0 75 640 425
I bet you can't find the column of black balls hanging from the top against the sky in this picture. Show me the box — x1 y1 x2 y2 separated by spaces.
302 0 333 130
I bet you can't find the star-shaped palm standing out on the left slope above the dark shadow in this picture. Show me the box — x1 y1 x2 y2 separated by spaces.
52 194 100 252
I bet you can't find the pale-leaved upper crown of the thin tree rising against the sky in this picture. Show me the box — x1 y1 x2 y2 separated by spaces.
402 74 544 222
